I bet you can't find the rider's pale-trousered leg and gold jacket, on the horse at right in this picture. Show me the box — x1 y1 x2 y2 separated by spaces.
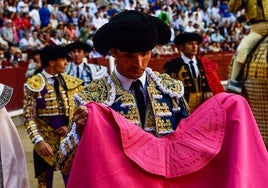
227 0 268 93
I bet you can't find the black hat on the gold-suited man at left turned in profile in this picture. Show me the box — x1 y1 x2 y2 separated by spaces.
40 45 68 68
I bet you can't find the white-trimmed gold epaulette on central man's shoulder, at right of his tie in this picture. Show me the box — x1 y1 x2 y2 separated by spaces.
155 72 184 96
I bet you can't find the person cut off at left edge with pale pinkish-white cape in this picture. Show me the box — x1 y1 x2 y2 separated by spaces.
0 83 30 188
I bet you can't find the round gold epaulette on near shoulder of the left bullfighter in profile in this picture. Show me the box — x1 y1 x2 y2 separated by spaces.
24 73 45 92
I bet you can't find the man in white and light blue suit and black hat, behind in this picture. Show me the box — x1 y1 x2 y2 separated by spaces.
66 41 107 85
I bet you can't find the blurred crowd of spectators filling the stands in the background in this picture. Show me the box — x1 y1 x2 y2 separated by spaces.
0 0 250 68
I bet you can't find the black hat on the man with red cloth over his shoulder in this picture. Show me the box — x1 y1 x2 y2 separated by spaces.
174 32 202 45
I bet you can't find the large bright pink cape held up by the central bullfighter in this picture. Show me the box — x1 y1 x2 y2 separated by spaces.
68 93 268 188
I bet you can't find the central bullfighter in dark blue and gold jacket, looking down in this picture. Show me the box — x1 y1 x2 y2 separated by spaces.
57 11 189 174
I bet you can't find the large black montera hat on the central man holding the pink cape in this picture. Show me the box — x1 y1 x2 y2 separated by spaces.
93 10 171 54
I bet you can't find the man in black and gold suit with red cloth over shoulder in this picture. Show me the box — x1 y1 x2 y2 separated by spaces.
164 32 224 112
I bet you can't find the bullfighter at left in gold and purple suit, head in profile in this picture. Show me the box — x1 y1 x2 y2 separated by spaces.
23 46 83 187
